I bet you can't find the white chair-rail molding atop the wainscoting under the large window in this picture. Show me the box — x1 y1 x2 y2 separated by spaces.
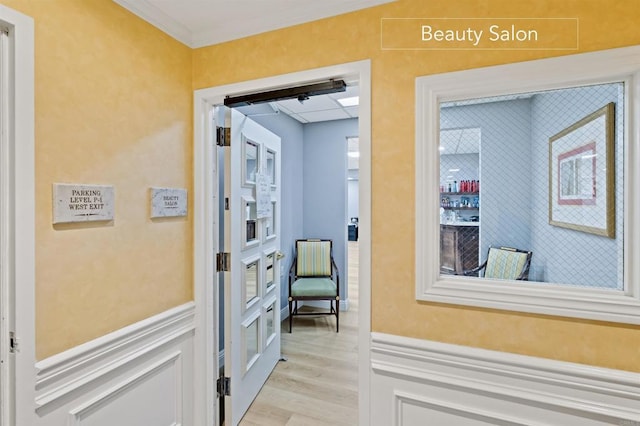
370 333 640 425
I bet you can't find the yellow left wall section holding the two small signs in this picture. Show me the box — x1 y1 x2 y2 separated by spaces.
1 0 193 359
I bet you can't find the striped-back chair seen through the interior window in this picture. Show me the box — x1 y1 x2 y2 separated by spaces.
464 247 532 281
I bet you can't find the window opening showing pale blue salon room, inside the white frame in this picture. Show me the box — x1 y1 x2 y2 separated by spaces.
438 82 625 291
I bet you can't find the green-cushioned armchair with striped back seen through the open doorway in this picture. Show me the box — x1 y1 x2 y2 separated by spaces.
289 239 340 333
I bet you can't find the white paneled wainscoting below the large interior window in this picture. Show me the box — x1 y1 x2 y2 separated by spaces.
371 333 640 426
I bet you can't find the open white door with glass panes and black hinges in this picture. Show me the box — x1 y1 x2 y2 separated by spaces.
224 110 281 426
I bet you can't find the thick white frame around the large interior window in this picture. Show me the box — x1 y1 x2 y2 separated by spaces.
415 46 640 324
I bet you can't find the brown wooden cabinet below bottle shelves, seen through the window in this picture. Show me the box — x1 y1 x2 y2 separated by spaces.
440 225 479 275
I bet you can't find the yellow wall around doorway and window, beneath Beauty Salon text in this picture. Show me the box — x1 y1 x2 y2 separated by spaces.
193 0 640 371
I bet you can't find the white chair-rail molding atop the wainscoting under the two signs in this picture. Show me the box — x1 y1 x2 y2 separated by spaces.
35 302 195 412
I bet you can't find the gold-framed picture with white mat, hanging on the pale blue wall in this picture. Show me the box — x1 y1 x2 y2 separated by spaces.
549 102 615 238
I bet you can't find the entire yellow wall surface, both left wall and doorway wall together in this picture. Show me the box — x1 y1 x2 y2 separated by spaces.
5 0 640 371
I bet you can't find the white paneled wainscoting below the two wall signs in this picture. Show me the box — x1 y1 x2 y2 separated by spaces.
35 302 195 426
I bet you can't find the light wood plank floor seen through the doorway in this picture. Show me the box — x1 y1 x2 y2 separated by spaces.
240 241 358 426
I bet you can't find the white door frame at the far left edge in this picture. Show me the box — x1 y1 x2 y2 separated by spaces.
0 5 36 426
